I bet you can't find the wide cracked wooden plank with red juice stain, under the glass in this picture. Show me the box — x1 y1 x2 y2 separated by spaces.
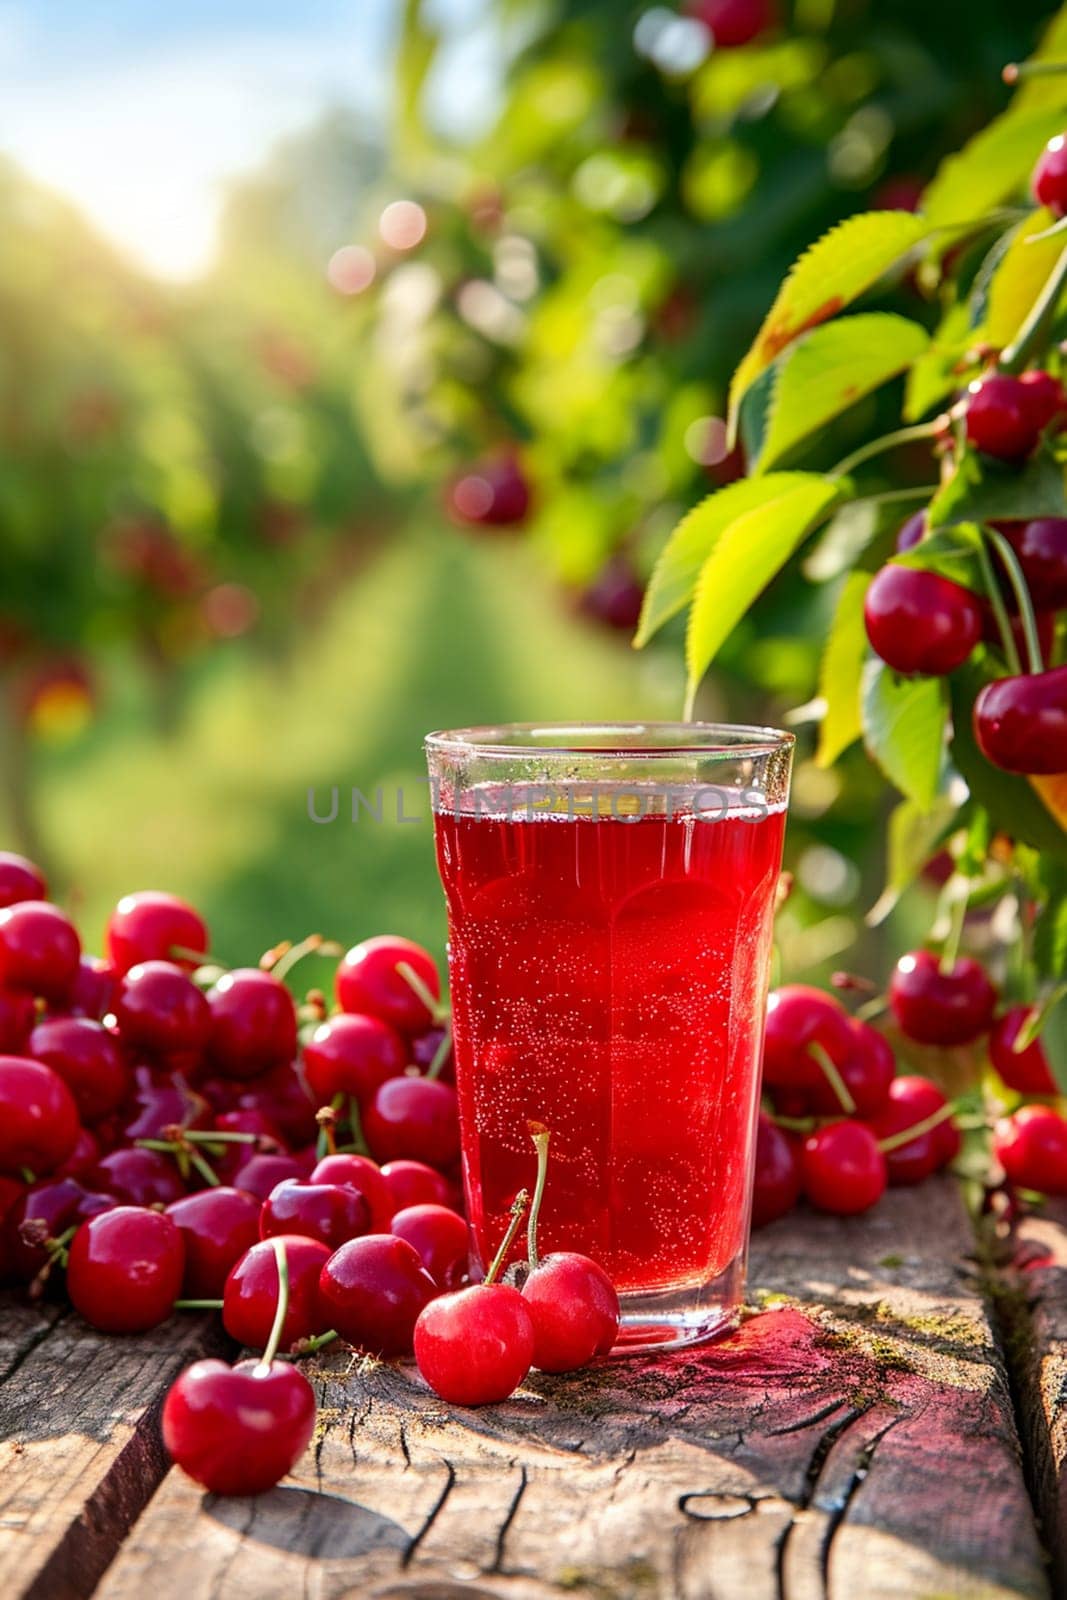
85 1182 1049 1600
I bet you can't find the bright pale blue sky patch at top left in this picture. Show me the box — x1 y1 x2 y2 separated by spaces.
0 0 494 277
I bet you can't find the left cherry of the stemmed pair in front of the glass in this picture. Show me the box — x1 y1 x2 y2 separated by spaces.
414 1283 534 1405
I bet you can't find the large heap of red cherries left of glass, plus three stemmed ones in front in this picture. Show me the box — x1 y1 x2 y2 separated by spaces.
0 854 619 1493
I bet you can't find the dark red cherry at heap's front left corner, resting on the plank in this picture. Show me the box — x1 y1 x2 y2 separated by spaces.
67 1205 186 1333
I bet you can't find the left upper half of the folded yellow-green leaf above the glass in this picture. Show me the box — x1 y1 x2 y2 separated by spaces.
633 472 822 648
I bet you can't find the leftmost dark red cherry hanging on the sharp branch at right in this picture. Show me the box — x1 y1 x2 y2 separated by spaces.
864 565 982 677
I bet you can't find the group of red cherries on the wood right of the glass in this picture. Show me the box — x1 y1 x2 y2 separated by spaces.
752 949 1067 1227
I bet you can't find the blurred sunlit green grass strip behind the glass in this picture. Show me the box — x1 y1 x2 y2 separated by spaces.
37 523 681 962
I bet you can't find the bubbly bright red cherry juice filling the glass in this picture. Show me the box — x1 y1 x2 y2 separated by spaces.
435 786 785 1290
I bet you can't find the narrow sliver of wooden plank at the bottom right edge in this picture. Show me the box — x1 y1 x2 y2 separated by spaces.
998 1200 1067 1594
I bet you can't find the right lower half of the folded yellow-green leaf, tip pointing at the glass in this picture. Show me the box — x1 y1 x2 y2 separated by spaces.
685 472 841 701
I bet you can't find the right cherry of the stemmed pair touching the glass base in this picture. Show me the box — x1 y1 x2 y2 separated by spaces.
524 1250 619 1376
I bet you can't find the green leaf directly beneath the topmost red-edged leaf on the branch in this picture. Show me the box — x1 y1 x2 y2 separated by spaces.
760 312 929 470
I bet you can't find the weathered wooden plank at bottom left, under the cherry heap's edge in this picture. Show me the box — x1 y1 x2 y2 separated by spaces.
0 1298 221 1600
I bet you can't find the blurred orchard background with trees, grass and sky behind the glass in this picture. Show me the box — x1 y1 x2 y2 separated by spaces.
0 0 1054 974
